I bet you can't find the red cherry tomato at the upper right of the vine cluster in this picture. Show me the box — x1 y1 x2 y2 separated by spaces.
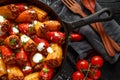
91 56 103 68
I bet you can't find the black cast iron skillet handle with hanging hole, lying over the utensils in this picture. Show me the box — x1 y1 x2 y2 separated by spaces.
70 8 112 28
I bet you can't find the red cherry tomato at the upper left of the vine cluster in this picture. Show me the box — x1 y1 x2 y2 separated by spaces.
76 60 89 71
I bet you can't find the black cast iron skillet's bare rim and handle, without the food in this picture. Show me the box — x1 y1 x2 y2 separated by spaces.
0 0 112 79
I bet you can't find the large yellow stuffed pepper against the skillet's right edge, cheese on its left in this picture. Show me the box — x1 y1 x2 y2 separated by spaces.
44 43 63 68
